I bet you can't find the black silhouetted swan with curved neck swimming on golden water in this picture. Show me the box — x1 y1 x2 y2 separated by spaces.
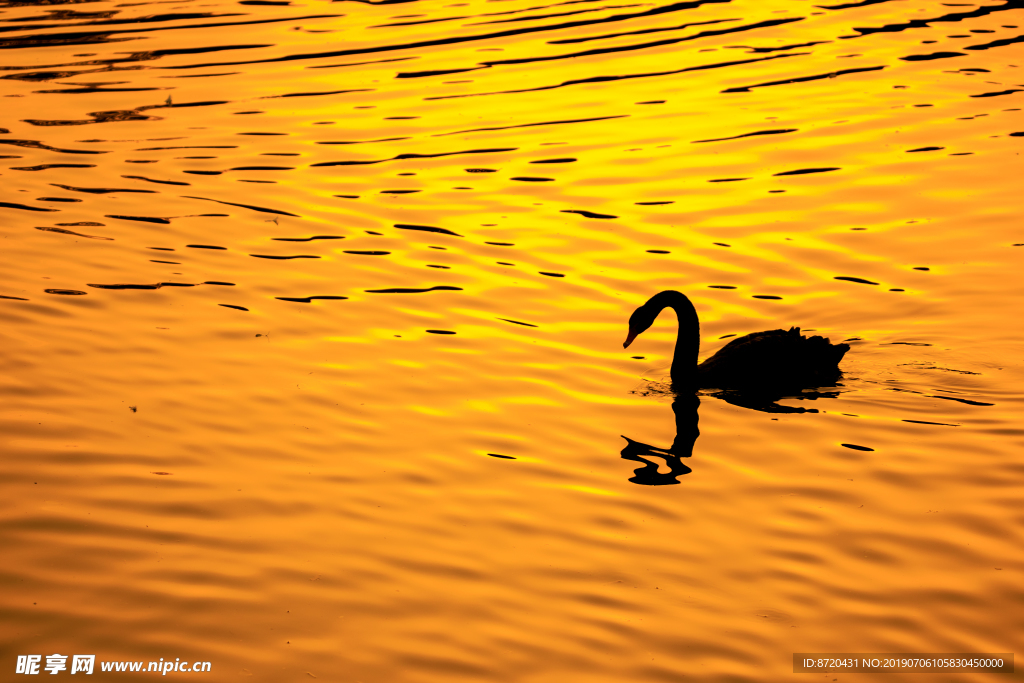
623 290 850 393
